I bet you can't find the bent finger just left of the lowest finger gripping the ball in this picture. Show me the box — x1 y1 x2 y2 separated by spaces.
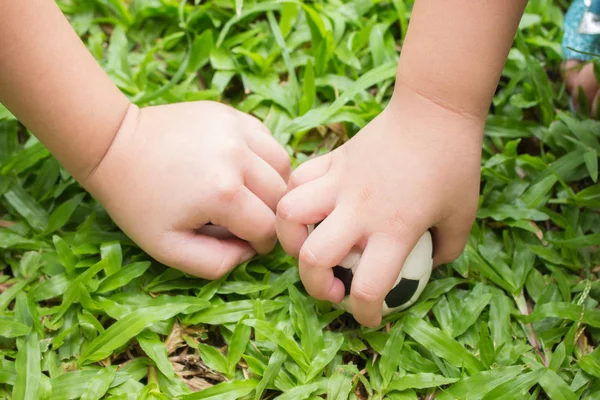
299 208 360 303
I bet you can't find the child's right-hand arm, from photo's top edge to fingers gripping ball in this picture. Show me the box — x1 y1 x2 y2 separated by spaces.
277 0 526 327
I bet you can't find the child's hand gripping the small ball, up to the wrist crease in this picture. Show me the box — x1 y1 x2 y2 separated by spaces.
277 89 483 327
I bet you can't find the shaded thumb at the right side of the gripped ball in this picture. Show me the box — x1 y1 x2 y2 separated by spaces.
431 217 472 268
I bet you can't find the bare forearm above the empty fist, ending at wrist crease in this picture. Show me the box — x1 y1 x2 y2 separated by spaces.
0 0 130 179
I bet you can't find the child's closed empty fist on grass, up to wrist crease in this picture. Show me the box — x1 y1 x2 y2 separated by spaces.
82 101 290 279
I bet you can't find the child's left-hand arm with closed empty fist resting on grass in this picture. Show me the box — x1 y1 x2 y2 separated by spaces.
0 0 290 279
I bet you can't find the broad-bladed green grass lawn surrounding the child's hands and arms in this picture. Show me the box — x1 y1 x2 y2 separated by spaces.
0 0 600 400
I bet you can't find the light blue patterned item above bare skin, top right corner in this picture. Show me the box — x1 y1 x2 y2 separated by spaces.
562 0 600 61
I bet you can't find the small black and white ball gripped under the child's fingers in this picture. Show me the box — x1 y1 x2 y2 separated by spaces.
308 224 433 316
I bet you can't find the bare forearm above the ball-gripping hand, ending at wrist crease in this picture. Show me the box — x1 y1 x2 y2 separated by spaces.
396 0 527 120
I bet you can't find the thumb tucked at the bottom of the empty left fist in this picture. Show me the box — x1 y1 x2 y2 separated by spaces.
154 231 255 280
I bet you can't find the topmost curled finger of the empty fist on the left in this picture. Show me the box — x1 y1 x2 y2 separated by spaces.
243 114 292 182
